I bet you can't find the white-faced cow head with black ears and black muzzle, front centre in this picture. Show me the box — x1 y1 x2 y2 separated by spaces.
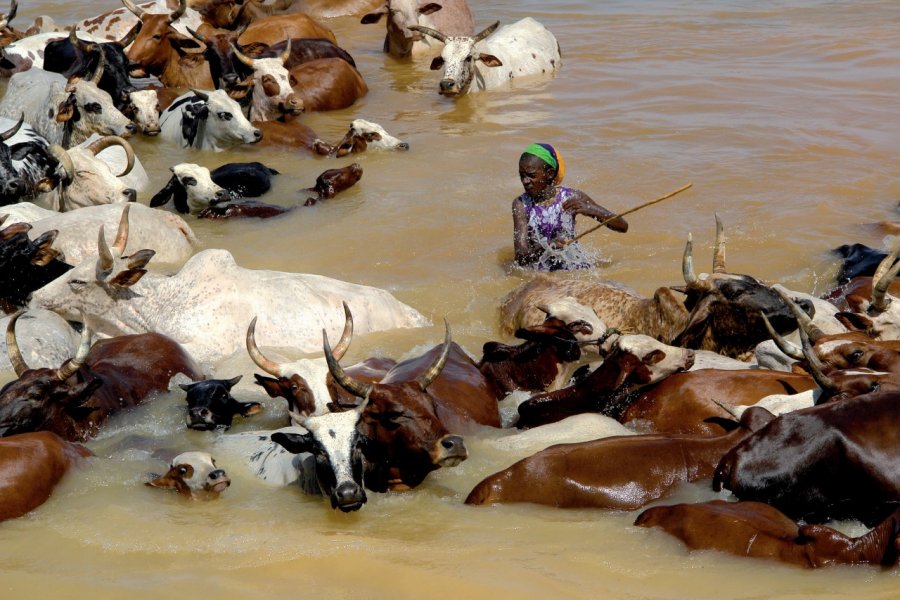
272 401 366 512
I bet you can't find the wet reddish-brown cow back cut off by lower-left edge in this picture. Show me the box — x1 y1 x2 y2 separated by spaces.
0 431 92 521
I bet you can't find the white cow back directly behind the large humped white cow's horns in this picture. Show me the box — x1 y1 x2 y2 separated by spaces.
0 202 200 264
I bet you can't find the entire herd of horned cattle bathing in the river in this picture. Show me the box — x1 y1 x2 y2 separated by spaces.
0 0 900 567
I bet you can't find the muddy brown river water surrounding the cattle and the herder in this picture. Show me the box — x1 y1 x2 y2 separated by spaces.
0 0 900 600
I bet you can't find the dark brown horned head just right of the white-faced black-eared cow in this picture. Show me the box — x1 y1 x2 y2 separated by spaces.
323 324 468 490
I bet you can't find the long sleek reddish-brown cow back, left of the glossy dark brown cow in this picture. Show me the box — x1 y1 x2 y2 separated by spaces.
466 409 773 510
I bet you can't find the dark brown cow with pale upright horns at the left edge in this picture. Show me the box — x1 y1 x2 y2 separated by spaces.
0 313 203 440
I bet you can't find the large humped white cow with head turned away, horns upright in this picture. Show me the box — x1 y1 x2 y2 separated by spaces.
31 204 428 364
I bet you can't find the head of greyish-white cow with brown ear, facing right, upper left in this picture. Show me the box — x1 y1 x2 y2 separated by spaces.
55 66 135 145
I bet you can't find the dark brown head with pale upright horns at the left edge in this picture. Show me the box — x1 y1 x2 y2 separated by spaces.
0 311 102 440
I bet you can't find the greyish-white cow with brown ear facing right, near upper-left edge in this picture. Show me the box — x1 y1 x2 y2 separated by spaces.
0 69 135 146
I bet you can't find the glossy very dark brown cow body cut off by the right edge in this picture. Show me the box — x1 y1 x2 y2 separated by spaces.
713 391 900 526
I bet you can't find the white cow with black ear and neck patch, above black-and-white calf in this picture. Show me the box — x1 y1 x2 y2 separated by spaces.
159 90 262 151
